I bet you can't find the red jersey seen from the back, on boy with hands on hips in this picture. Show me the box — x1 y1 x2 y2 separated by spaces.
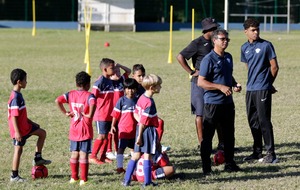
57 90 96 141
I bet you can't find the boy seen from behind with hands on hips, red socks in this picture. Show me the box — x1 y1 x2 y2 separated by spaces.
55 71 96 186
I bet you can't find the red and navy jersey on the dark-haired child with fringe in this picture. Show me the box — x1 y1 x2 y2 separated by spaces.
111 96 137 139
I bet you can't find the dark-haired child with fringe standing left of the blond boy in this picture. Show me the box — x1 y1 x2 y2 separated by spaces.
110 78 138 173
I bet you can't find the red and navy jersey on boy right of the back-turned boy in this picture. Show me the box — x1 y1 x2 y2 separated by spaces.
92 75 114 121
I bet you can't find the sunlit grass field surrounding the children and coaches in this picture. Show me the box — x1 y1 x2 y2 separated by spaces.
0 29 300 190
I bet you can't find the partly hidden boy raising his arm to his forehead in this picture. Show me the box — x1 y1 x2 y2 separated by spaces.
106 63 131 159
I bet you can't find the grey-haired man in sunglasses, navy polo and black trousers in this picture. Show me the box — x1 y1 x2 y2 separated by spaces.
198 29 241 174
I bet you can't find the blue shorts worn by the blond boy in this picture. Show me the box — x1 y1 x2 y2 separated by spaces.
134 126 158 154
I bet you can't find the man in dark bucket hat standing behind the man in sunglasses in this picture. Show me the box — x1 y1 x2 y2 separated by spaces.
177 18 222 154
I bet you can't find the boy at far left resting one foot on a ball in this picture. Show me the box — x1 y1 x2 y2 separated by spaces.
8 69 51 182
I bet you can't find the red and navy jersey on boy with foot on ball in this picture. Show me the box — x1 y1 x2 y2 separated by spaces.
8 91 32 138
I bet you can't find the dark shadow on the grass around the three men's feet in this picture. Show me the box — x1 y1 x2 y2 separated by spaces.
169 142 300 183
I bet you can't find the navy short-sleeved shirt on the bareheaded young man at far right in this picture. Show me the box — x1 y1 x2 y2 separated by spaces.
241 39 276 91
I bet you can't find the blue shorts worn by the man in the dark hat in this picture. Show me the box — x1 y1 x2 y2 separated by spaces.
191 82 204 117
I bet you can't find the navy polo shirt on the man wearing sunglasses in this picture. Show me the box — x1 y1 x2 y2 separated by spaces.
199 51 233 104
